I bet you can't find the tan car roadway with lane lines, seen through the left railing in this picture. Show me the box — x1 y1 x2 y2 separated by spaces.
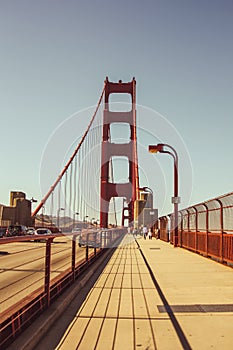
0 236 85 313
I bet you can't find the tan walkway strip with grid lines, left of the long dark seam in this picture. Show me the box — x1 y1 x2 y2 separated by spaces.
52 237 179 350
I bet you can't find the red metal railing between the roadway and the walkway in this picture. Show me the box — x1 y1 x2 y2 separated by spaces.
0 228 126 349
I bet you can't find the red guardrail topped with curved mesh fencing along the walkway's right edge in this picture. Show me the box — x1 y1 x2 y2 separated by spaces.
159 192 233 264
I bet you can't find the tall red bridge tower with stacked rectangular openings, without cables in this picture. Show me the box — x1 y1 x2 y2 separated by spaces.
100 78 139 227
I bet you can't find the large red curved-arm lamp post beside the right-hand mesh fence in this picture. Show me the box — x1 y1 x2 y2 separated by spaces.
149 143 180 247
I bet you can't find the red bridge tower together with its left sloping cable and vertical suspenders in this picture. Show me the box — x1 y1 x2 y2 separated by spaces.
32 78 139 228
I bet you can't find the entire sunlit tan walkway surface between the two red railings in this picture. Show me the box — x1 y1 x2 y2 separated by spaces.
10 236 233 350
